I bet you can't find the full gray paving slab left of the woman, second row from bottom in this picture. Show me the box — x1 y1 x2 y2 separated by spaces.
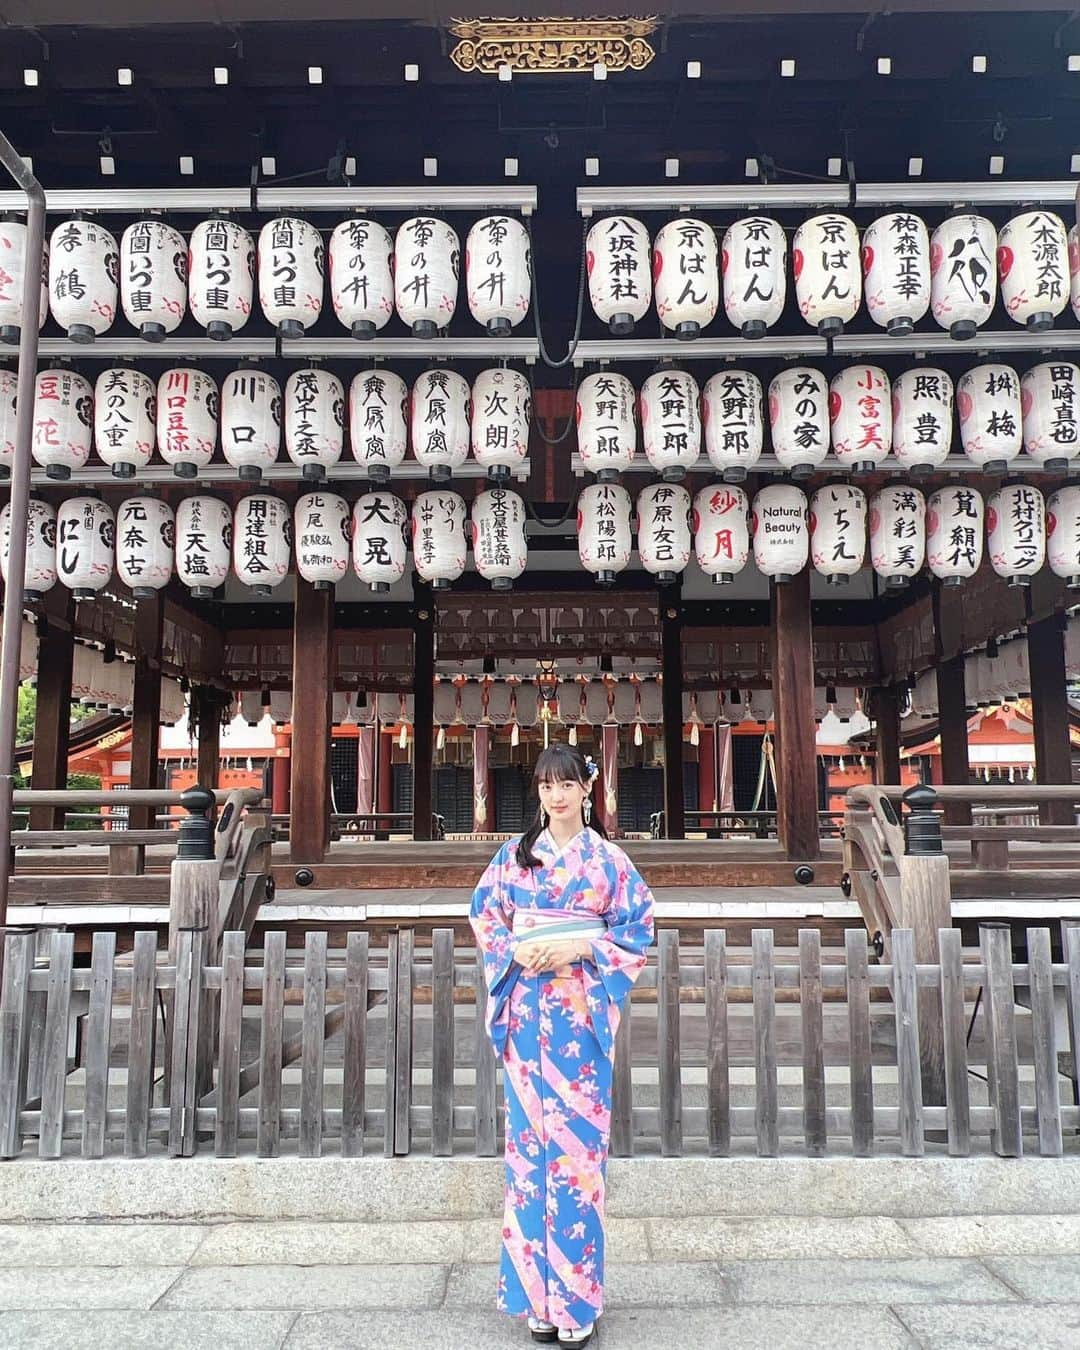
161 1265 447 1312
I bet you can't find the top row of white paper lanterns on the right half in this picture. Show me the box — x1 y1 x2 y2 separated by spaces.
586 211 1080 339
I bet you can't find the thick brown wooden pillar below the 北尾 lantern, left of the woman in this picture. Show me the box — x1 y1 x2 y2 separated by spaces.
289 576 333 863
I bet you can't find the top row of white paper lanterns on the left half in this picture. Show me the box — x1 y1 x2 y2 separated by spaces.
0 216 532 343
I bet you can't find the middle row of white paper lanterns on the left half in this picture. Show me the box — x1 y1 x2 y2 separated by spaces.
7 366 532 482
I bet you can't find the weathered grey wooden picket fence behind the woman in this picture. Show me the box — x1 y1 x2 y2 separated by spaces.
0 925 1080 1158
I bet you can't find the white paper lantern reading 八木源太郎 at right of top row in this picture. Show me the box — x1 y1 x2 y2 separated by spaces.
998 211 1069 332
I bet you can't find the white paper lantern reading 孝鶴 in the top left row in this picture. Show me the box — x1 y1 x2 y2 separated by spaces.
49 220 120 343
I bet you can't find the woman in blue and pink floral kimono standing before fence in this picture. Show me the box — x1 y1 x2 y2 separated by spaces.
471 744 653 1346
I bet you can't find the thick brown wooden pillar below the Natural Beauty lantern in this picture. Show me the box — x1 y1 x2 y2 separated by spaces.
771 567 819 859
